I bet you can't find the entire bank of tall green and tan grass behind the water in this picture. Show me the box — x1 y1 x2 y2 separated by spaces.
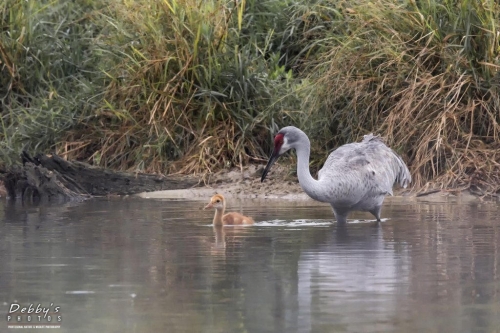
0 0 500 192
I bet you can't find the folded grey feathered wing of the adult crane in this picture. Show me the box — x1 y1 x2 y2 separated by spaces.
318 134 411 195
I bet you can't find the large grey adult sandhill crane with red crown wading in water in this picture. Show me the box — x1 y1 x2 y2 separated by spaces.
261 126 411 224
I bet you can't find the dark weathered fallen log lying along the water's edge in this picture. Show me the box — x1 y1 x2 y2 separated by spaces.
0 152 199 201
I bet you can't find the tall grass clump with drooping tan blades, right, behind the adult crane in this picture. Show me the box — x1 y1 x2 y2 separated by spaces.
305 0 500 192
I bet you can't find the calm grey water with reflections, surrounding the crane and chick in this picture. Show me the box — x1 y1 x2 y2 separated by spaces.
0 198 500 332
